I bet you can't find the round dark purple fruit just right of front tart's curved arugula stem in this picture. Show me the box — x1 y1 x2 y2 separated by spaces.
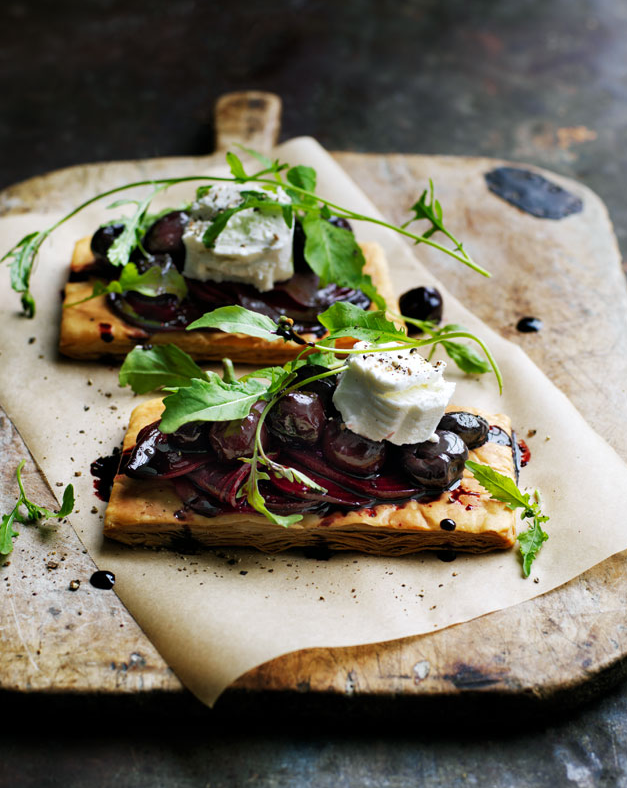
268 391 325 446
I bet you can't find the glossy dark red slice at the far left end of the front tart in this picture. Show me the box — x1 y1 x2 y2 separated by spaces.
120 421 211 479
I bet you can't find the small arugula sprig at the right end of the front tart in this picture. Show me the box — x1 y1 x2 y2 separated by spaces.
466 460 549 577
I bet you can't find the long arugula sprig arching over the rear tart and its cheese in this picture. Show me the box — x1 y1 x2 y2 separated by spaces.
0 148 489 317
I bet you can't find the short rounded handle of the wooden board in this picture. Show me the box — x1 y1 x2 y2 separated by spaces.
215 90 282 153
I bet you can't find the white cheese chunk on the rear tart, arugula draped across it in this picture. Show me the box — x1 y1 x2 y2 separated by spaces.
183 183 294 291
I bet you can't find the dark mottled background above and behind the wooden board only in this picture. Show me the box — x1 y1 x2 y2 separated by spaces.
0 0 627 249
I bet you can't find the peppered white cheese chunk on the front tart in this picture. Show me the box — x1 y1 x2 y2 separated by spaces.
333 342 455 446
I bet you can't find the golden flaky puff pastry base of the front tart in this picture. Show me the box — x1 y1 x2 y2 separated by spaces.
104 400 516 556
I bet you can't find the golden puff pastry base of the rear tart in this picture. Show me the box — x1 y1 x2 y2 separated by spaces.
59 238 398 366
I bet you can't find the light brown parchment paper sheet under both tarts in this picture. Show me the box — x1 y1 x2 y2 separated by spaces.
0 138 627 705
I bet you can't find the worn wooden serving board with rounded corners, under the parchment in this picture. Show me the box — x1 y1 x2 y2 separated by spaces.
0 93 627 706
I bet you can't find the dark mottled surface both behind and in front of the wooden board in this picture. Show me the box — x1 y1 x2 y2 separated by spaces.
0 0 627 788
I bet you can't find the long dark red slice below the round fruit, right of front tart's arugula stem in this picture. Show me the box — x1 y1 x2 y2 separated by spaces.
287 448 423 501
